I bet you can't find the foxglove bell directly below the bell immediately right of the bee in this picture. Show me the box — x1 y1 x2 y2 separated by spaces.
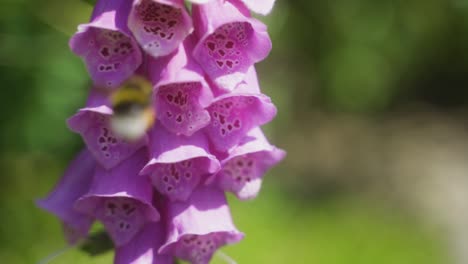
141 124 220 201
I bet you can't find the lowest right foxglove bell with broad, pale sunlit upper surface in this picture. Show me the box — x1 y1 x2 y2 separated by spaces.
159 187 244 264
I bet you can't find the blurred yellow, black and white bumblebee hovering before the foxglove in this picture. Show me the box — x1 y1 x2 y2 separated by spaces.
110 75 156 141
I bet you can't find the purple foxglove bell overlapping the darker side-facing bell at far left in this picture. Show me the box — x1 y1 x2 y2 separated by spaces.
75 149 159 246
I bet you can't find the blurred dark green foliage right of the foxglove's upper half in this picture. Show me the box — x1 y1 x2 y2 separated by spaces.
264 0 468 114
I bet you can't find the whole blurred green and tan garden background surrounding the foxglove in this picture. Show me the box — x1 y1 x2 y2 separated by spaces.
0 0 468 264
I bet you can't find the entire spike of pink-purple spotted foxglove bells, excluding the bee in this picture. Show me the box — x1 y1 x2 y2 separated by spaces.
39 0 285 264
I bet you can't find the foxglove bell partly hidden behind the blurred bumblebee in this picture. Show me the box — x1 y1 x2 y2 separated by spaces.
68 89 145 169
